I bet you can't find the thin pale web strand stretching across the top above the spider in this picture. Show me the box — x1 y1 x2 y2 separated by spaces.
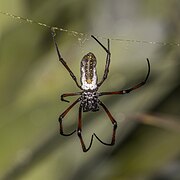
0 11 180 47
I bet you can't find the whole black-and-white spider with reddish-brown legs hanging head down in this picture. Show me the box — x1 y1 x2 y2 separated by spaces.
52 30 150 152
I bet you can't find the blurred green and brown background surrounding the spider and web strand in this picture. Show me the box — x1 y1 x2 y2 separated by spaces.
0 0 180 180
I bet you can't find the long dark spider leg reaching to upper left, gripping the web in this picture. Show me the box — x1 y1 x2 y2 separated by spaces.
51 29 82 89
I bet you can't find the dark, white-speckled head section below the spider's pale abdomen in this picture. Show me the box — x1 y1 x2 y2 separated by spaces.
81 91 99 112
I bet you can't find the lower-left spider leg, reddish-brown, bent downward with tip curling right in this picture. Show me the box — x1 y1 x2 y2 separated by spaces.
59 98 81 136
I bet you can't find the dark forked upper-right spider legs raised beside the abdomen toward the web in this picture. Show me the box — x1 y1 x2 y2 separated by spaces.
91 35 111 87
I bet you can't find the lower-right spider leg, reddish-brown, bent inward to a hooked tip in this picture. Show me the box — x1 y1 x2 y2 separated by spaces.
94 101 117 146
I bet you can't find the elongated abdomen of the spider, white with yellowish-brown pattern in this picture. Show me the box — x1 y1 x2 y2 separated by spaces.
81 52 97 90
